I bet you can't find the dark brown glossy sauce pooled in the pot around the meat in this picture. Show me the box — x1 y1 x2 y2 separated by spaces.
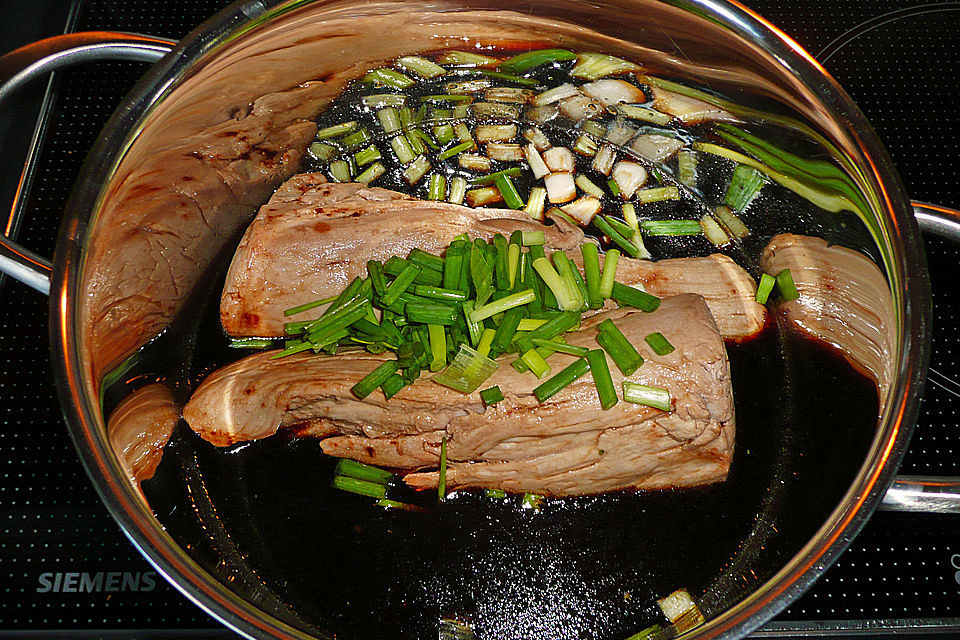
129 47 878 639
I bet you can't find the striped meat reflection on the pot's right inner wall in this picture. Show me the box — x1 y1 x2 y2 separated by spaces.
761 233 897 408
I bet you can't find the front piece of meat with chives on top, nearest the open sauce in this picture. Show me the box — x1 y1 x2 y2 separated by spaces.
184 295 734 496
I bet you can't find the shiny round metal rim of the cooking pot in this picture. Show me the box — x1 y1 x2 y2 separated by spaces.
50 0 932 639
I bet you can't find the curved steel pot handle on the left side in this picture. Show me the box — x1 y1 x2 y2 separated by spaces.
0 31 176 294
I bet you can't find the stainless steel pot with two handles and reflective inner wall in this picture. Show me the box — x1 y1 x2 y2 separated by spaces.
0 0 960 638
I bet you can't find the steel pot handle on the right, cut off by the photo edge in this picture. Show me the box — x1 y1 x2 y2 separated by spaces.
880 202 960 513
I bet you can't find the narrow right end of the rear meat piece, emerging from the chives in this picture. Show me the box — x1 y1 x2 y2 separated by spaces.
571 251 767 340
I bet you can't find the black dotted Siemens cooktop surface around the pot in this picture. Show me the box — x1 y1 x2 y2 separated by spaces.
0 0 960 635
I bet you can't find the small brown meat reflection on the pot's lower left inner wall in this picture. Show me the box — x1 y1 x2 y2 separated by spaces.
107 382 180 485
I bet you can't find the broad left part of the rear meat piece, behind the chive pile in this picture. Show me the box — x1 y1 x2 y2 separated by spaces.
220 173 583 336
